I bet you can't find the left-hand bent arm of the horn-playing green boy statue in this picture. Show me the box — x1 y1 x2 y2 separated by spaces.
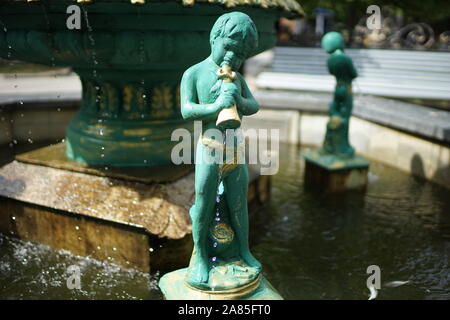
180 70 234 121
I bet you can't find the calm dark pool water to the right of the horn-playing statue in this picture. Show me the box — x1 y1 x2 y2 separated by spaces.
253 146 450 299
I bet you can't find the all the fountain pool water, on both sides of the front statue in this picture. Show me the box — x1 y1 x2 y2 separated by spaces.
0 145 450 299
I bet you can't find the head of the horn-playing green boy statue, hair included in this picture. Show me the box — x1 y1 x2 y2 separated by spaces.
209 12 258 70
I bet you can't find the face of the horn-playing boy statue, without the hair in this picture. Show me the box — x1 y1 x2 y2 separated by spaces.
211 34 247 70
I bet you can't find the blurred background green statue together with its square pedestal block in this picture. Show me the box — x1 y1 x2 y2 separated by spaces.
303 31 369 192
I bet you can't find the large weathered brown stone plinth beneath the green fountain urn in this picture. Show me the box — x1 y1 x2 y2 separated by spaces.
0 144 270 272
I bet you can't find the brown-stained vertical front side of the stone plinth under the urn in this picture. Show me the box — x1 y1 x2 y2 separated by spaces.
0 198 153 272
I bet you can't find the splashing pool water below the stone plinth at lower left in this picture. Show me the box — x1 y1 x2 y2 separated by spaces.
0 234 161 299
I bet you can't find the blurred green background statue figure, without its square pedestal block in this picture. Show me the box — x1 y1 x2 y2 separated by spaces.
320 32 358 157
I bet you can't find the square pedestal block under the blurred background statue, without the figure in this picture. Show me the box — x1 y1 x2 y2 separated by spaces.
304 151 369 192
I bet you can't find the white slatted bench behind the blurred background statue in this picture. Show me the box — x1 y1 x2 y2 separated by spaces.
256 47 450 100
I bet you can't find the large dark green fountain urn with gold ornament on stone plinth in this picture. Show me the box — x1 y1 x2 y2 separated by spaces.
0 0 303 166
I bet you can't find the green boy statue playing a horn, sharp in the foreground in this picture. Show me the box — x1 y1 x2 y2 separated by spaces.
180 12 261 290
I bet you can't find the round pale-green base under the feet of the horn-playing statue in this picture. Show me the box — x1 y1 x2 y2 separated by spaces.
159 268 283 300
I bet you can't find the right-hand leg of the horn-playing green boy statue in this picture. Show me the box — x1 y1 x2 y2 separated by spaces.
224 164 261 270
